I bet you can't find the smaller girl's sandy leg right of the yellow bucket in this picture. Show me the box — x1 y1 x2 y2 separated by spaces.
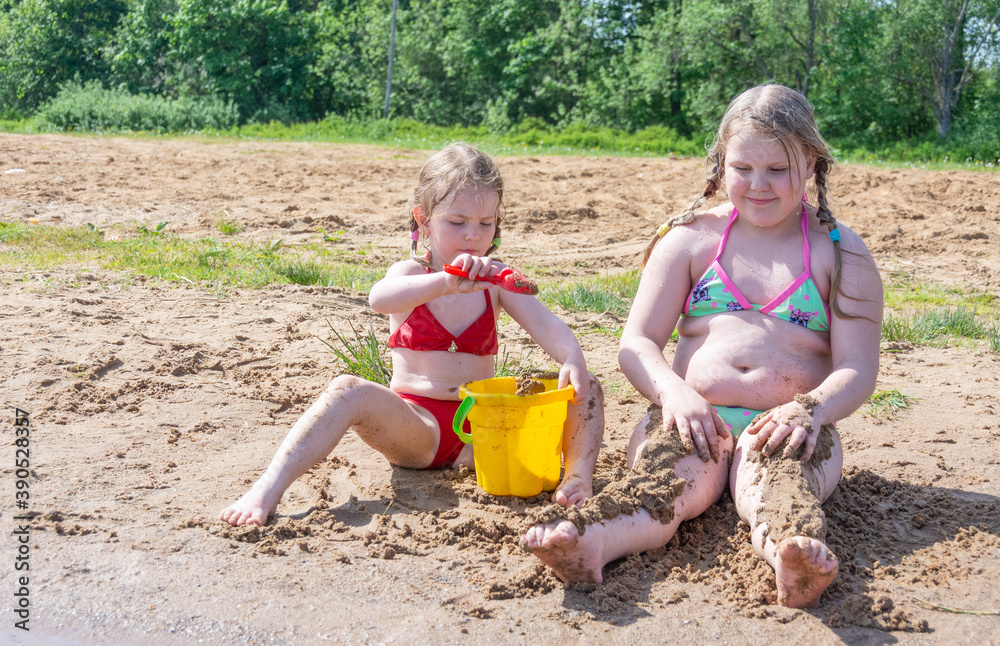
552 375 604 507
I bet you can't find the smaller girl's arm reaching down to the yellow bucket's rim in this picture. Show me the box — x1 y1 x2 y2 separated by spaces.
500 289 590 404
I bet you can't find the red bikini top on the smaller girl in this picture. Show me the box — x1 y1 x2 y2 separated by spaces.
389 290 500 356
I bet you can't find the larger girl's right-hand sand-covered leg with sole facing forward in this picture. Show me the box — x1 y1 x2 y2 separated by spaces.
731 425 843 608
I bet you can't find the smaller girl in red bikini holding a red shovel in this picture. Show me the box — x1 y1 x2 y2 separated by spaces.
220 144 604 525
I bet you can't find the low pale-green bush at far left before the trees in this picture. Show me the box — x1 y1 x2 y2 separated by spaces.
37 81 237 133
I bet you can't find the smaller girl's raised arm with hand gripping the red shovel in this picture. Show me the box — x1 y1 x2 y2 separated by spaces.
368 256 491 314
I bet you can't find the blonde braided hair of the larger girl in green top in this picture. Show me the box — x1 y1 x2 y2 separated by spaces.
642 85 857 318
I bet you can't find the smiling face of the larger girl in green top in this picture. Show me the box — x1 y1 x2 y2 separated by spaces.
726 132 816 227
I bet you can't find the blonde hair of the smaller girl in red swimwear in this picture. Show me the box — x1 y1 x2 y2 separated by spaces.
408 143 504 267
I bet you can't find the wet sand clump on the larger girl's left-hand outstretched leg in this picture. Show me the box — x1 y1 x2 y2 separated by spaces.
529 405 692 534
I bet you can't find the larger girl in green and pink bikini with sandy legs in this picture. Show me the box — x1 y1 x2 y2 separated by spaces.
522 85 882 608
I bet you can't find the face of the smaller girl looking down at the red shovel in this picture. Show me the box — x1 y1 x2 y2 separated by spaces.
420 187 500 266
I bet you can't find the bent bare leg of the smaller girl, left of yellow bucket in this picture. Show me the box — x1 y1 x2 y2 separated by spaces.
219 375 437 526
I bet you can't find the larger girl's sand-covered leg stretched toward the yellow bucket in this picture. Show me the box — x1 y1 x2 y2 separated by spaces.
521 408 732 583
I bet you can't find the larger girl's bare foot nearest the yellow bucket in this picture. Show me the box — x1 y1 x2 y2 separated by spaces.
521 520 604 583
